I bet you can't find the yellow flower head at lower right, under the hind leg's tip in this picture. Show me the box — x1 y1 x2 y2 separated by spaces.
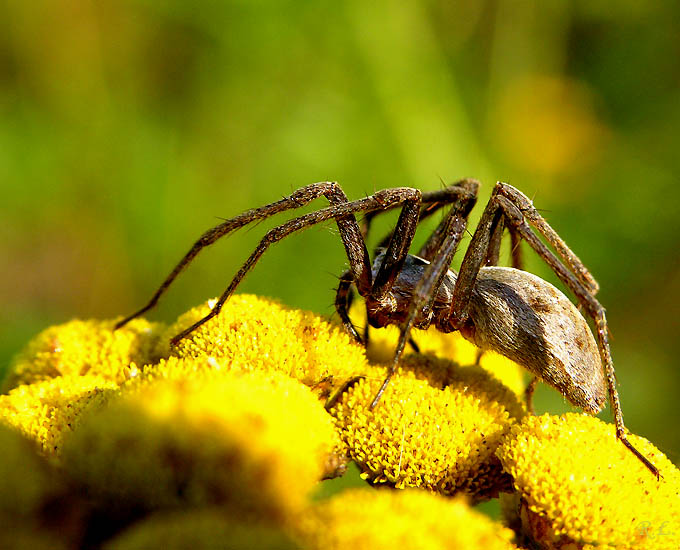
497 413 680 550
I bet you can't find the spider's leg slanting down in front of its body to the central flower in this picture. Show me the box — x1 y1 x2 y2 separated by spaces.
371 187 477 409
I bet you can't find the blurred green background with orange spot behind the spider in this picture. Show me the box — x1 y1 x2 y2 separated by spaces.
0 0 680 463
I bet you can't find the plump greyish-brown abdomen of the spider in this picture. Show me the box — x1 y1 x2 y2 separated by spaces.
462 267 606 414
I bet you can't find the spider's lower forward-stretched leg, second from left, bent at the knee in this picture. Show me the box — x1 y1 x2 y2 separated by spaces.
171 189 420 344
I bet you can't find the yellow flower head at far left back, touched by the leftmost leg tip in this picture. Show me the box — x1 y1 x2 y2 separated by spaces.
3 319 161 392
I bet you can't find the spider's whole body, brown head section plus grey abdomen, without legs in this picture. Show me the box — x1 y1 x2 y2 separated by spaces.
367 251 606 413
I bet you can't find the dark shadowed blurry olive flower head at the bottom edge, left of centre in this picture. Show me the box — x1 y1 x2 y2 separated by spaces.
103 508 298 550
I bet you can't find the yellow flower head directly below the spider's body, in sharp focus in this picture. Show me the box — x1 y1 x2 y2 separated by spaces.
330 355 524 498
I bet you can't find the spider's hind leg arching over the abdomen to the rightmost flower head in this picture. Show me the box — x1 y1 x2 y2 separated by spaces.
452 183 659 478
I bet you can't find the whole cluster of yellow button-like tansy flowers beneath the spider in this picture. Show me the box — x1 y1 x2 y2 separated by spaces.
0 295 680 550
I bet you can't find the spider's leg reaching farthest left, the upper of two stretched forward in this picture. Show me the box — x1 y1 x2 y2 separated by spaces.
115 182 371 328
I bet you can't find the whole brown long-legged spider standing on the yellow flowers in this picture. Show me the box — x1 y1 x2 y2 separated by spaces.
116 179 659 478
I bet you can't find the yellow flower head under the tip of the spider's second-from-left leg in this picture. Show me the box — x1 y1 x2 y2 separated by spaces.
159 294 366 391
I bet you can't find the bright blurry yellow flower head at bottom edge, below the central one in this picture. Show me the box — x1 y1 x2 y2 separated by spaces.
300 489 515 550
